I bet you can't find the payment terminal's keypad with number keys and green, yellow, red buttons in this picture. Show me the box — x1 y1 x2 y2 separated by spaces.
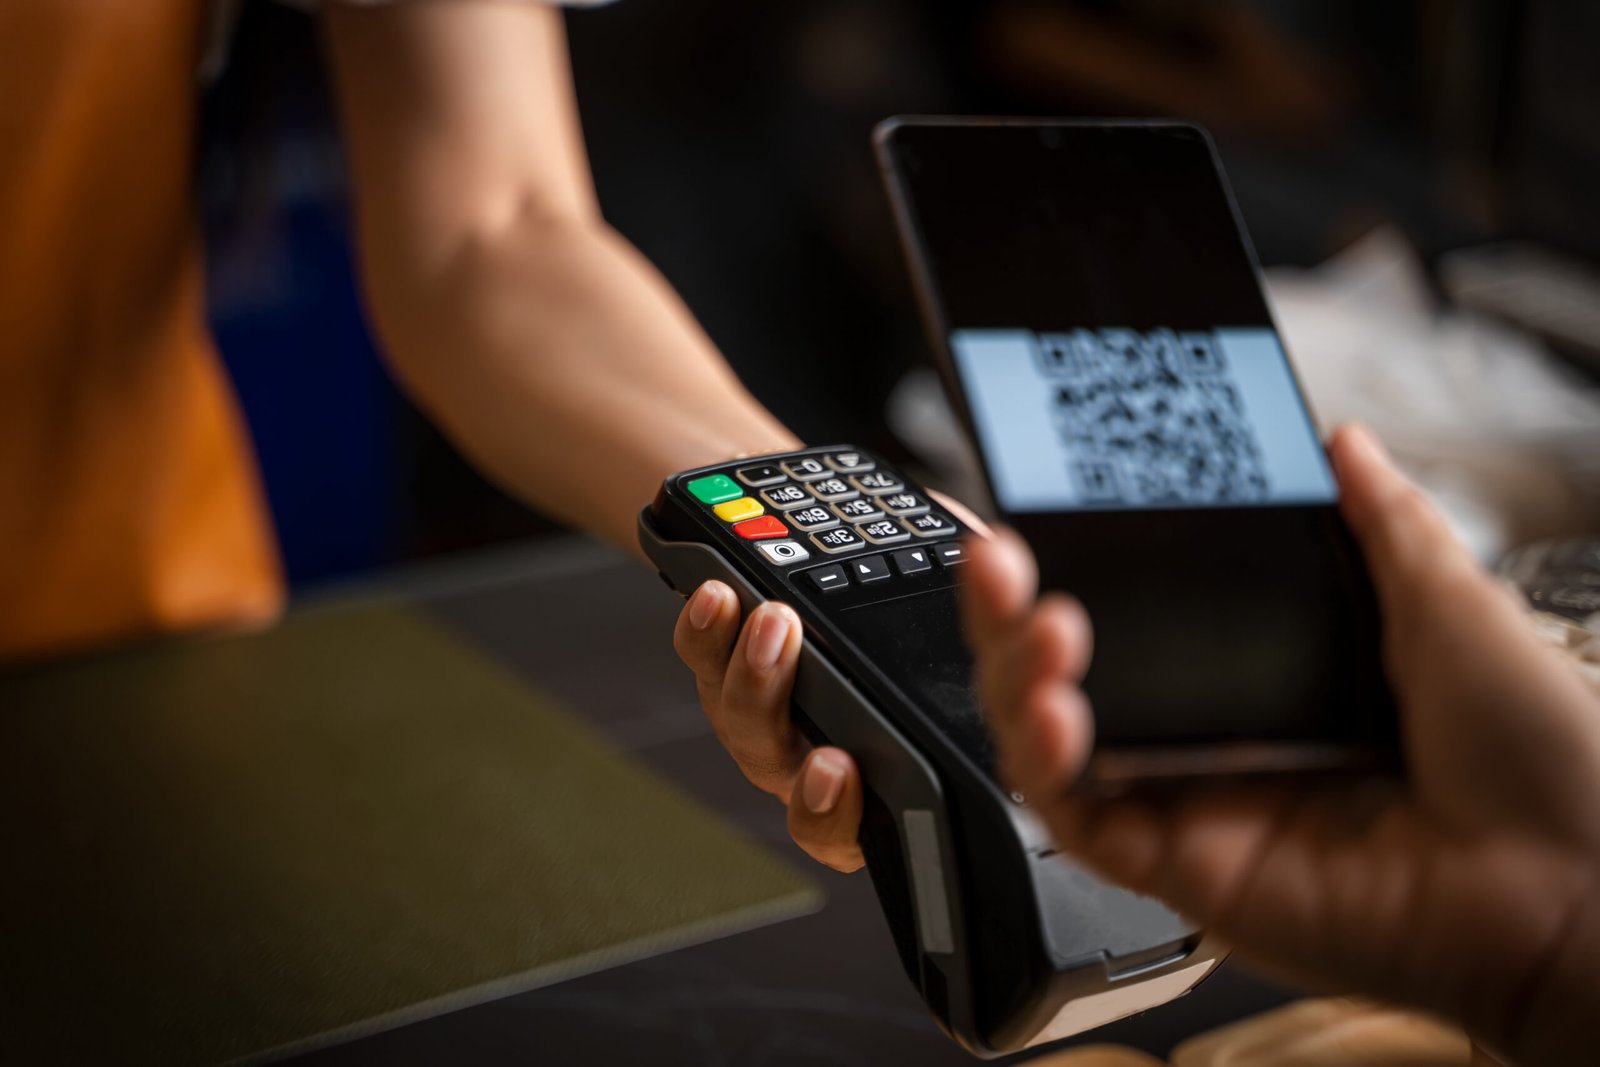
682 448 965 591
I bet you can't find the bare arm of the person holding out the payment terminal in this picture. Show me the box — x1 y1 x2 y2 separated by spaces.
326 0 794 549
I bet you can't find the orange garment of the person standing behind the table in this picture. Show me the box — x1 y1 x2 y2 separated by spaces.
0 0 283 661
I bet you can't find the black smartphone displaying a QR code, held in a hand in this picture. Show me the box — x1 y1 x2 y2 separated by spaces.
875 118 1397 782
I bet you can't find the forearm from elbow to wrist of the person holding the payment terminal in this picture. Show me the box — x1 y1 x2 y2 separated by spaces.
368 216 797 550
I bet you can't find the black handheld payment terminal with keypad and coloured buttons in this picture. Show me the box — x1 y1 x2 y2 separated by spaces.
638 446 1226 1057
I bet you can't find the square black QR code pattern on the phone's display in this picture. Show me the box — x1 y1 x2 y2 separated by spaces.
1038 330 1269 506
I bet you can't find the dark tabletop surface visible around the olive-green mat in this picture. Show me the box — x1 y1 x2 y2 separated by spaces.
15 539 1291 1067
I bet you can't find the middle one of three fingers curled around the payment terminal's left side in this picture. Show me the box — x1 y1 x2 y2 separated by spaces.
712 600 806 803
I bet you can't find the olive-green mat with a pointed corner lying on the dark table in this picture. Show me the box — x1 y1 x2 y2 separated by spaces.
0 608 818 1064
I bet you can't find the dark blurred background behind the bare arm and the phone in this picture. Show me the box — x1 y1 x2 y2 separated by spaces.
197 0 1600 587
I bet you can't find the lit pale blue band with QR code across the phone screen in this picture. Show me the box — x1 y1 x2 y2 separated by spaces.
950 325 1336 512
